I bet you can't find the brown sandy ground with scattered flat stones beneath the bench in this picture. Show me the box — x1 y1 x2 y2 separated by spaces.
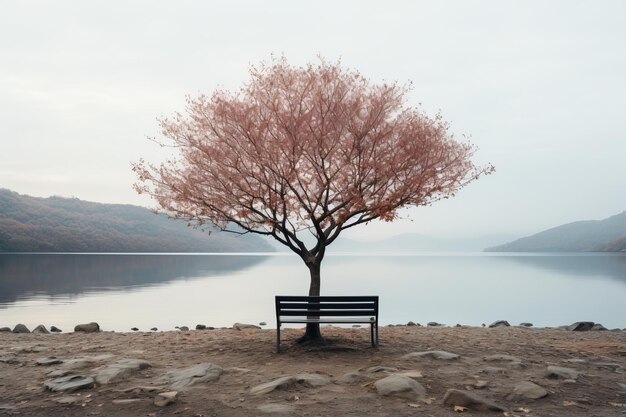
0 326 626 417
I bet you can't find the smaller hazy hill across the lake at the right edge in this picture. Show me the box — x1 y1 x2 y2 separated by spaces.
485 211 626 252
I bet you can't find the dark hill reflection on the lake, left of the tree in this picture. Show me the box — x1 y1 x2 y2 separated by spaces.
0 254 267 308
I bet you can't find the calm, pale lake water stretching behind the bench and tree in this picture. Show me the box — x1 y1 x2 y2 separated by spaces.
0 253 626 331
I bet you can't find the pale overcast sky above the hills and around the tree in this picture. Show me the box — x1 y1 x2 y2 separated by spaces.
0 0 626 238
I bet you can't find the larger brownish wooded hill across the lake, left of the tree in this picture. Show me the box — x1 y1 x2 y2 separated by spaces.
0 188 274 252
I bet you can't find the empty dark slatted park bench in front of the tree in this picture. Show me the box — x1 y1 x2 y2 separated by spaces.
276 295 378 352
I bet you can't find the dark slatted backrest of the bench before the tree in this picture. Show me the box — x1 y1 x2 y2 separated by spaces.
276 295 378 317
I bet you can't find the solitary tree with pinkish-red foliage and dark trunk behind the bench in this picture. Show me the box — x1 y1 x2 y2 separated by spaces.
133 58 493 340
